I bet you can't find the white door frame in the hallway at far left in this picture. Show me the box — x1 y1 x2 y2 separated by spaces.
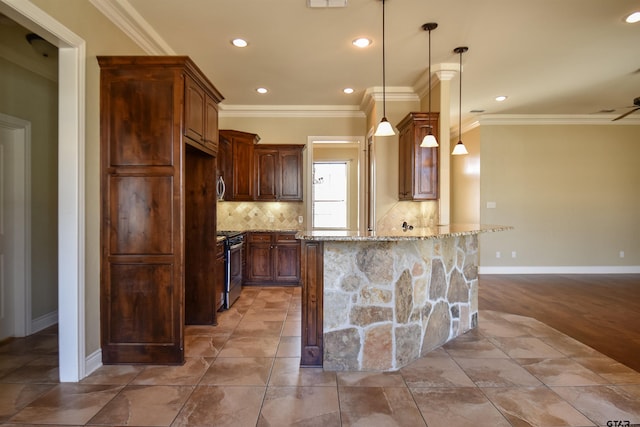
0 113 33 337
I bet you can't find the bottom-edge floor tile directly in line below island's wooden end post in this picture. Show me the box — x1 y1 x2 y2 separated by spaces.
257 387 340 427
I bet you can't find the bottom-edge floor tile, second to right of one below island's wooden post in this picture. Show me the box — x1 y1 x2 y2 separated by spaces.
411 387 511 427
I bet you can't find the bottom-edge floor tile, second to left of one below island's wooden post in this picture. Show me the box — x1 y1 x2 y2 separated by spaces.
89 386 194 426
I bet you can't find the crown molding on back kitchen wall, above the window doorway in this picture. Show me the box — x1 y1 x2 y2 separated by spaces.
218 103 366 118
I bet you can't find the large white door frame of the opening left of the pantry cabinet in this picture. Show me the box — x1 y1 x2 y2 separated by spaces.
0 0 86 382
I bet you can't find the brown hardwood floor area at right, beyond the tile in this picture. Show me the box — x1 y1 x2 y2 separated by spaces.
478 274 640 371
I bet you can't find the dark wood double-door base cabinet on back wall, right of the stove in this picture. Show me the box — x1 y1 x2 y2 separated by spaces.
244 232 300 285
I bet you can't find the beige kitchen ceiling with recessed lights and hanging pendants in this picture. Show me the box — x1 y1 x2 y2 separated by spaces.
23 0 640 127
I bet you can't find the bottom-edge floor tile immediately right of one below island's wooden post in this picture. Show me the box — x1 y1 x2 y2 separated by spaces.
338 386 426 427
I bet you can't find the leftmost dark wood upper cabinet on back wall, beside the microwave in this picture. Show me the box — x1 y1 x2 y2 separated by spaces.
219 129 260 201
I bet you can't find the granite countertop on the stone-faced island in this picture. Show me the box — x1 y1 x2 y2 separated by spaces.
296 224 513 242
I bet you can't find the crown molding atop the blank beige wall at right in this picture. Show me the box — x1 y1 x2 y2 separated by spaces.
478 114 640 126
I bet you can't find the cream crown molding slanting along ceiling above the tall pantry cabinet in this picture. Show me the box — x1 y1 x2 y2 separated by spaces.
89 0 176 55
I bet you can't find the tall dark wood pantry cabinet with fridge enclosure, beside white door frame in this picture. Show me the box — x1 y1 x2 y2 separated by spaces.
98 56 223 364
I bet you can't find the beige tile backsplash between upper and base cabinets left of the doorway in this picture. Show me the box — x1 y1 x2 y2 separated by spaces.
217 202 305 230
